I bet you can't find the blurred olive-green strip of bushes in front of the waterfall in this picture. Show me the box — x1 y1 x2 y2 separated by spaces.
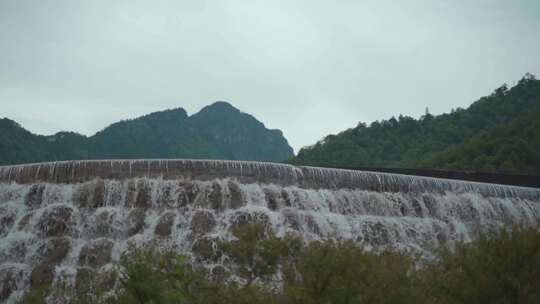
20 224 540 304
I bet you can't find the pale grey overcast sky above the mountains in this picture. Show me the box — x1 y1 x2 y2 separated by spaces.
0 0 540 151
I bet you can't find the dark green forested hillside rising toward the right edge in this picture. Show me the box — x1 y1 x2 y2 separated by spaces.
290 74 540 174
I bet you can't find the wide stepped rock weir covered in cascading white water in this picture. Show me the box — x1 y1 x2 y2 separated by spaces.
0 160 540 303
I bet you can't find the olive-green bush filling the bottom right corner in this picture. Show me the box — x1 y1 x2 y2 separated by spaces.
423 227 540 303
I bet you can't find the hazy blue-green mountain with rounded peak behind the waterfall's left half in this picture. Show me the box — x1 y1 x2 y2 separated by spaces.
0 102 293 164
